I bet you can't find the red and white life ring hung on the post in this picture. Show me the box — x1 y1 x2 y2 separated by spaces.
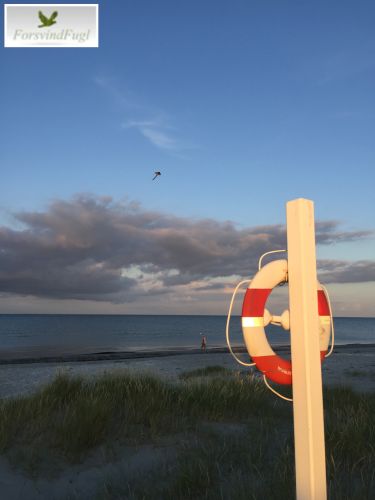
242 260 331 385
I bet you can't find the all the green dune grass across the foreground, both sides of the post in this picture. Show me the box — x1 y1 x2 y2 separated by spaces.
0 366 375 500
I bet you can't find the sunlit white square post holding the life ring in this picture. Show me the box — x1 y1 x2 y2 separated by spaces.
286 198 327 500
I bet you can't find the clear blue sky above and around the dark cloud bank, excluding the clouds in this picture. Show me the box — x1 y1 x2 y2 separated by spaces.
0 0 375 315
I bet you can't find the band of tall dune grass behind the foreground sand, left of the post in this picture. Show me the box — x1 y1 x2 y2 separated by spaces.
0 372 273 462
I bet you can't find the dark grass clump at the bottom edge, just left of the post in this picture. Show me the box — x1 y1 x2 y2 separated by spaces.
103 430 294 500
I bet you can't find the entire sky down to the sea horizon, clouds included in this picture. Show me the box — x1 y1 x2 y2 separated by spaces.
0 0 375 317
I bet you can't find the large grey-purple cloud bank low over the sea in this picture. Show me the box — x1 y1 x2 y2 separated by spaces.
0 195 375 303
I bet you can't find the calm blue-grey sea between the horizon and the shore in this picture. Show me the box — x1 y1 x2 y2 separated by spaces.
0 314 375 359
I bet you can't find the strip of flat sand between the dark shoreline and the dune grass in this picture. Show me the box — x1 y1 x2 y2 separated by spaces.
0 344 375 398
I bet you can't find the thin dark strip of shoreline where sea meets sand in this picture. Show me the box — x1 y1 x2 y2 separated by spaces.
0 343 375 366
